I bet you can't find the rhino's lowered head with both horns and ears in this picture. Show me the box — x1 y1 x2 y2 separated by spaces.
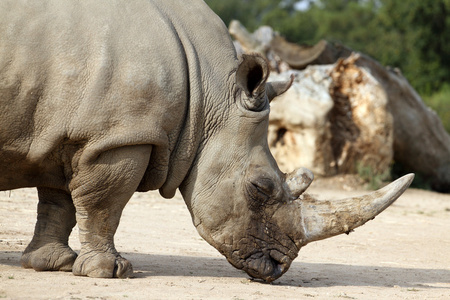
181 55 413 282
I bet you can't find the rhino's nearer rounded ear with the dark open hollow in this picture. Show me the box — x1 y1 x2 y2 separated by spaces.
236 53 269 111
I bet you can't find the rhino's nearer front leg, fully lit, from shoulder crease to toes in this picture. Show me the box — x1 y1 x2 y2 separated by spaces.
70 146 151 278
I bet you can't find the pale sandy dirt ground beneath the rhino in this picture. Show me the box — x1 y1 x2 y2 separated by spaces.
0 177 450 299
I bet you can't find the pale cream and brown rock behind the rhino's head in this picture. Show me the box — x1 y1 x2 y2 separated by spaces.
269 55 393 176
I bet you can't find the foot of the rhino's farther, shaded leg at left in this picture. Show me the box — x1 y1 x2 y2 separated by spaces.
20 243 77 272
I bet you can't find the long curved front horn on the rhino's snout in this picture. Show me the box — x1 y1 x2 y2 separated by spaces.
299 174 414 245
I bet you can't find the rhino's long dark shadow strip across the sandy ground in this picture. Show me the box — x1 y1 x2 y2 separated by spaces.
0 251 450 289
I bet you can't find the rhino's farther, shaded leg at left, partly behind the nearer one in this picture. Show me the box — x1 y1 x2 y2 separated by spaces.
21 188 77 271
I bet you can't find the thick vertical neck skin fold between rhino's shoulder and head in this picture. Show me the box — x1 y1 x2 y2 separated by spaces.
159 1 237 198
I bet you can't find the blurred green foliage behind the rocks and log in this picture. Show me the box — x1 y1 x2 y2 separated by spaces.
206 0 450 130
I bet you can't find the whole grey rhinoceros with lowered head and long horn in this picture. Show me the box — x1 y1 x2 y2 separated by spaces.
0 0 413 282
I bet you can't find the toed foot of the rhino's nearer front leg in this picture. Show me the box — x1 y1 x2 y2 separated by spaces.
72 251 133 278
